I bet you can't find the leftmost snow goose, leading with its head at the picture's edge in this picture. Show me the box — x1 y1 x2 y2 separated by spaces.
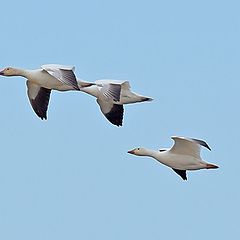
0 64 90 119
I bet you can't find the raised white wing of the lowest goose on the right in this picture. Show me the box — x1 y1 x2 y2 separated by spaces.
170 136 211 158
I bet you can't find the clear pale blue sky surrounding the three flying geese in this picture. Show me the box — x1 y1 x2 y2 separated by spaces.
0 0 240 240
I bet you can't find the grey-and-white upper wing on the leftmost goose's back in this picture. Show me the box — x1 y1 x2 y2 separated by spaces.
41 64 79 90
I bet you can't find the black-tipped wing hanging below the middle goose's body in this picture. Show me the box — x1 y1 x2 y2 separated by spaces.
97 99 124 127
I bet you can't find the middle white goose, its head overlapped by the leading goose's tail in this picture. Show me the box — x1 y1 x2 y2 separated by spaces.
78 80 153 126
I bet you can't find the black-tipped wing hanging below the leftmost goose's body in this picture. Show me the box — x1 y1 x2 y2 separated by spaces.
27 81 51 120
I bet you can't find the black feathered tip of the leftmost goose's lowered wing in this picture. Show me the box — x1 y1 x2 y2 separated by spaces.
30 87 51 120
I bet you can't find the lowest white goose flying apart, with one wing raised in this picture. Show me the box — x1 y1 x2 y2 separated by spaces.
128 137 218 180
